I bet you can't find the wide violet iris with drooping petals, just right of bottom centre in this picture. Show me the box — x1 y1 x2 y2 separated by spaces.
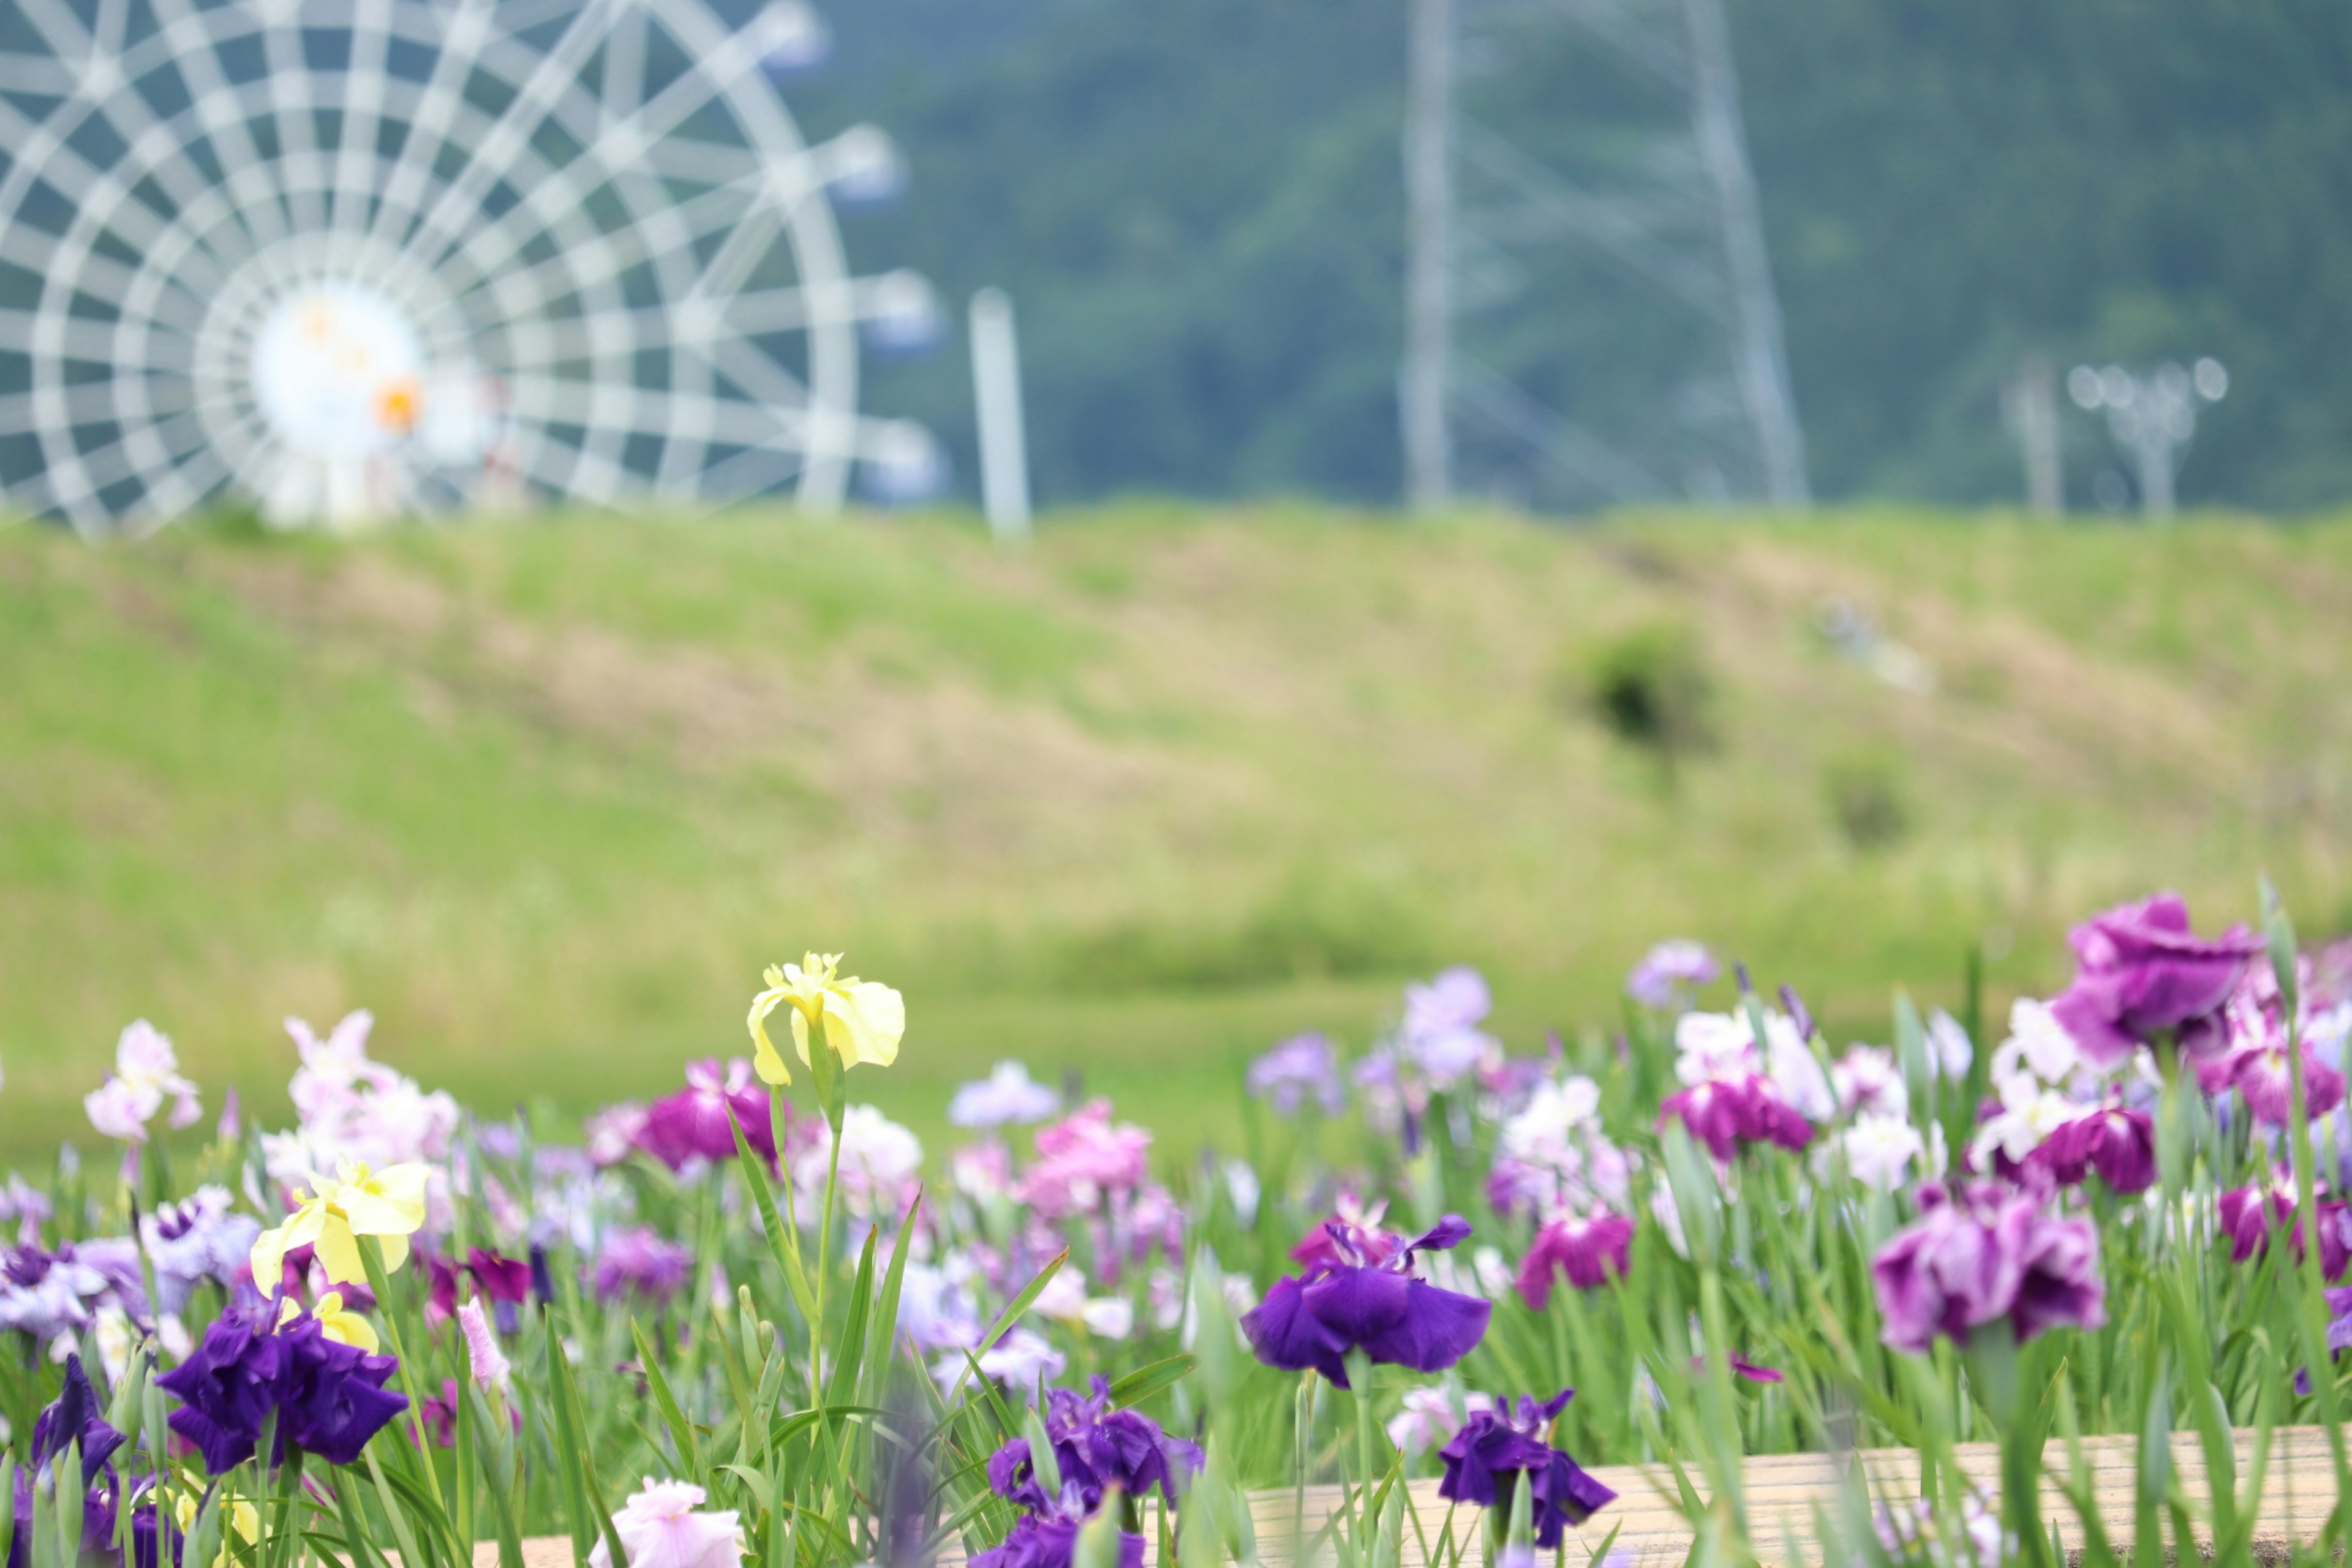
1242 1213 1493 1387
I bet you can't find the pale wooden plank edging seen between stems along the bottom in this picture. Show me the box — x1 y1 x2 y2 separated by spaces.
486 1427 2335 1568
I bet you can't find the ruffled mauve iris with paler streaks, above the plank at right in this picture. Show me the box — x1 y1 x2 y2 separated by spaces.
1870 1183 2108 1352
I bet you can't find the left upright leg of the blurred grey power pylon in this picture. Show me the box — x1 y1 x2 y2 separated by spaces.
1400 0 1453 510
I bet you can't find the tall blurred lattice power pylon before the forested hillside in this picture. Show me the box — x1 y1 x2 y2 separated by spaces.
1400 0 1811 513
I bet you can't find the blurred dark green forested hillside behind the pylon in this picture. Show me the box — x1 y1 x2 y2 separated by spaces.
790 0 2352 513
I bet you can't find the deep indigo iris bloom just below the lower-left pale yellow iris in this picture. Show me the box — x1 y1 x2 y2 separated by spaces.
155 1307 409 1476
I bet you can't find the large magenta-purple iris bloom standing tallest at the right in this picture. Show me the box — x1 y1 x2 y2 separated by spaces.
2051 893 2263 1067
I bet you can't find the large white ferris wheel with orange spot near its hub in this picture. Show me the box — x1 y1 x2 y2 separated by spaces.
0 0 938 533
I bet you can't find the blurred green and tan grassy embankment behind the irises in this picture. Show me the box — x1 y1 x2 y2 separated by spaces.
0 505 2352 1154
